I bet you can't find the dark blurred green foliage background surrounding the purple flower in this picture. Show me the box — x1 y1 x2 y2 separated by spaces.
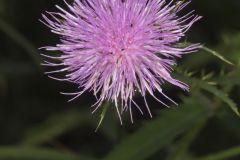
0 0 240 160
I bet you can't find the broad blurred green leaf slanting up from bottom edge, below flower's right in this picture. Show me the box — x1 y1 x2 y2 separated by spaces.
105 99 208 160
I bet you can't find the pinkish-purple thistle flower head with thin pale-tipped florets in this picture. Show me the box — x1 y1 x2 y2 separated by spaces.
42 0 201 123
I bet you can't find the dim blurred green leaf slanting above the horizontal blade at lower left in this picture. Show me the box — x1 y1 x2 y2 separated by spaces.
21 109 89 146
